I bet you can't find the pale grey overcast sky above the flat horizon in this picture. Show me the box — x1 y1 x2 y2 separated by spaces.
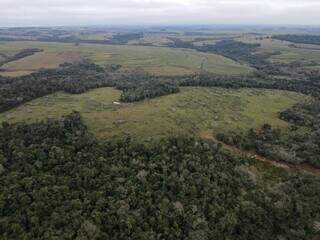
0 0 320 26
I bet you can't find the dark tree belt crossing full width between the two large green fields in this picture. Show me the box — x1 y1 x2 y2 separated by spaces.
0 59 320 111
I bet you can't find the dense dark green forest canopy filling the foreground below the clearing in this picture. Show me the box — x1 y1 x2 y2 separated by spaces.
0 113 320 240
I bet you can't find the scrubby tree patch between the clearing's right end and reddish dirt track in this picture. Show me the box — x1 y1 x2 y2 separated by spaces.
217 100 320 168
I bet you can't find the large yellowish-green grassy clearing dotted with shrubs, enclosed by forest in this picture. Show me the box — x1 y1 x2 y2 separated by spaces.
0 88 307 139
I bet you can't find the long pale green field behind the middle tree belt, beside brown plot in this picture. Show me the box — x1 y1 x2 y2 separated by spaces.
0 42 252 75
